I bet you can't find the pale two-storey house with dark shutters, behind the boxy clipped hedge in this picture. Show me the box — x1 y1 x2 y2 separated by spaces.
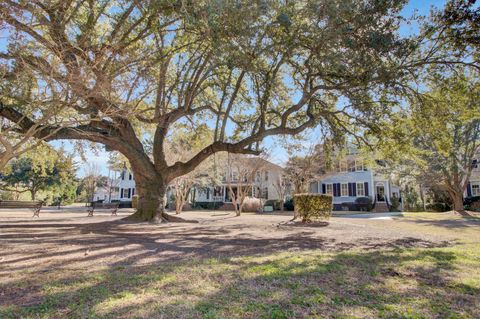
310 154 402 212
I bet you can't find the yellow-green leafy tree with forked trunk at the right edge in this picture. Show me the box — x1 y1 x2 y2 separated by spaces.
383 73 480 214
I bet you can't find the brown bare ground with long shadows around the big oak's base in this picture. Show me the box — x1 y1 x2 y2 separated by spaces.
0 207 480 318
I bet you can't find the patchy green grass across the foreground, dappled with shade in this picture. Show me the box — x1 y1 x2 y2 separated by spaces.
0 214 480 319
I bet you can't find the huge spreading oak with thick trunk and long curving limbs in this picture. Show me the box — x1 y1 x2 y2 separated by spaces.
0 0 454 221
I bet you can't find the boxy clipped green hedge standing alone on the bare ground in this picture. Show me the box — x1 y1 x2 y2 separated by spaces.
293 193 333 223
